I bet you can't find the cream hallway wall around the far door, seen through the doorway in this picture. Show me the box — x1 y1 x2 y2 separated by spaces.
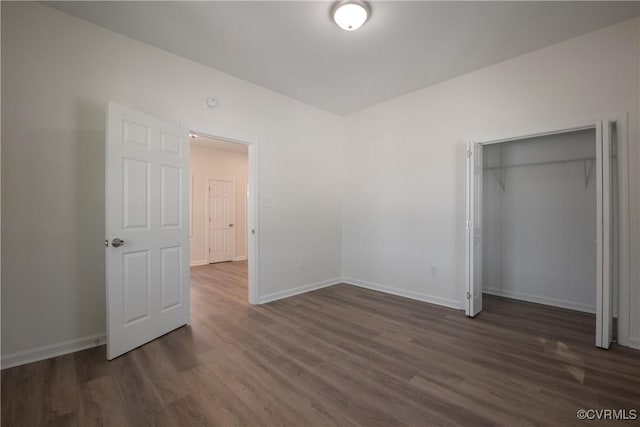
191 142 249 265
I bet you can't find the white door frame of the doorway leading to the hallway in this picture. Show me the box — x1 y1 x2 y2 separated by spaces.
190 130 260 305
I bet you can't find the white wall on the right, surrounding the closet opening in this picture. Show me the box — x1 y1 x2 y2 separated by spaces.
343 19 640 343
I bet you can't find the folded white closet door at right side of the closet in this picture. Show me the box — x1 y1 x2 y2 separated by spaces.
596 121 614 348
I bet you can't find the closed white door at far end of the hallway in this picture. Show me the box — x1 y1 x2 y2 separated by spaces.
209 179 235 263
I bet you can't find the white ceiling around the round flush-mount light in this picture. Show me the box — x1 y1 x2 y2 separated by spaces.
47 1 639 115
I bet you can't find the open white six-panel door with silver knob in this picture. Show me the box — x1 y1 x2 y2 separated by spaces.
105 103 190 360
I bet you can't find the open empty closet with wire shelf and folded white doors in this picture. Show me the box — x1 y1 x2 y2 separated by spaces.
467 121 628 348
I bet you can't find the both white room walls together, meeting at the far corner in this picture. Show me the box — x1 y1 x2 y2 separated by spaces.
1 2 640 362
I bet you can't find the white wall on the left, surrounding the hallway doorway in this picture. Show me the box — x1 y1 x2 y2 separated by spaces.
2 2 343 362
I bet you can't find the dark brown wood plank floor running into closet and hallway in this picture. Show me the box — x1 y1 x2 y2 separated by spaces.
2 263 640 427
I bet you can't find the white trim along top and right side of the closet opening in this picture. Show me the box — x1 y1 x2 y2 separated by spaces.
462 113 630 346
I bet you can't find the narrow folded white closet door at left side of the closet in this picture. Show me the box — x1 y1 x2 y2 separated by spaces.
465 143 482 317
